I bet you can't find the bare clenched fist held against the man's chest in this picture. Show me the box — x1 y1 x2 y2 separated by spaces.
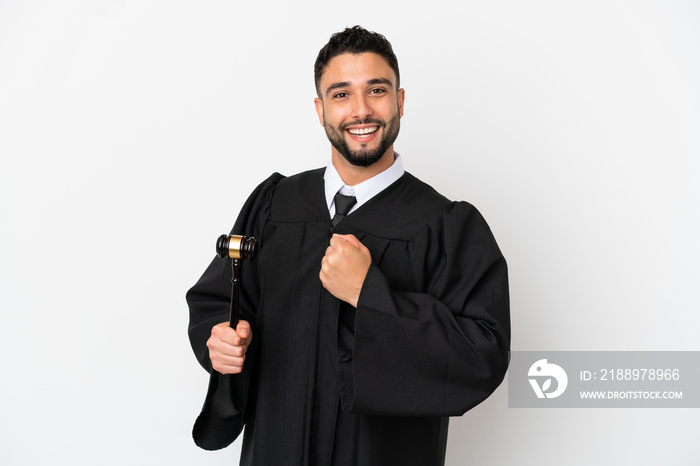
319 234 372 307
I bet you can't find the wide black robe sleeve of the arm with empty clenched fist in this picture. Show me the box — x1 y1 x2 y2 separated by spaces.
340 202 510 416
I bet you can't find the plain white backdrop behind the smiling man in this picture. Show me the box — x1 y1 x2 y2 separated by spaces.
0 0 700 466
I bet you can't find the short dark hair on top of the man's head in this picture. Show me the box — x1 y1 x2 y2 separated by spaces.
314 26 400 97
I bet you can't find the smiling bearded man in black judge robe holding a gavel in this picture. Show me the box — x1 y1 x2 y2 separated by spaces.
187 26 510 466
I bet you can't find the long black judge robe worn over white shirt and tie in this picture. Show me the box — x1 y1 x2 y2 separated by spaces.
187 169 510 466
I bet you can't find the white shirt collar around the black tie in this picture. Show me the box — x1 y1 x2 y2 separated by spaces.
323 153 404 217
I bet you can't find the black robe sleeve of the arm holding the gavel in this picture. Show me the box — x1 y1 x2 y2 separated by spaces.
186 173 282 450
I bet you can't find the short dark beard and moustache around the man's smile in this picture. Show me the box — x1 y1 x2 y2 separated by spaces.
323 113 401 167
